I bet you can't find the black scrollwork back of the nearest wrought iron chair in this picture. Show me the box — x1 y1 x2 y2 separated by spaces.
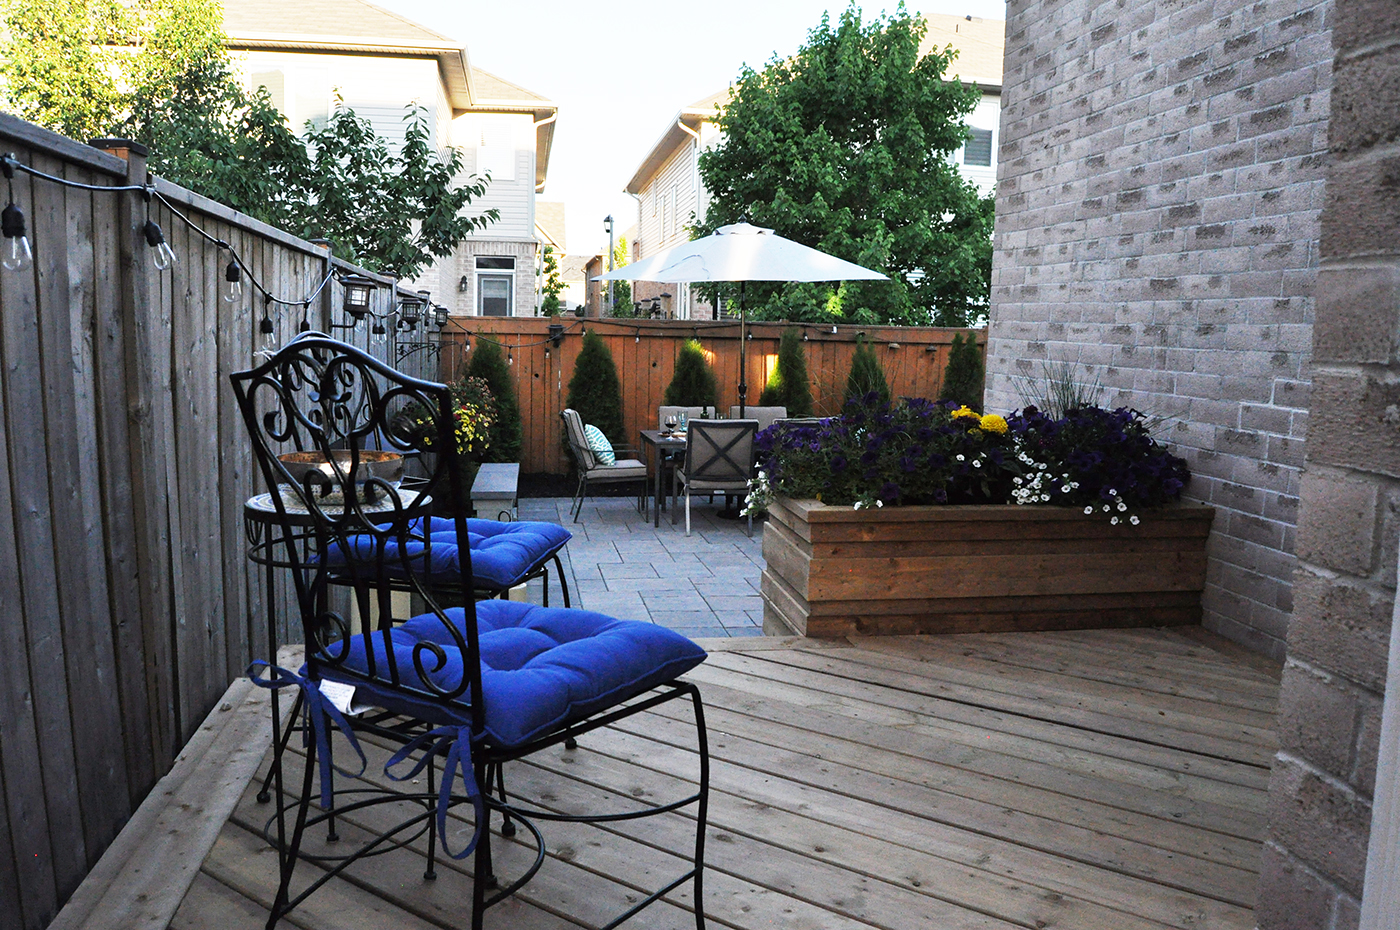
231 333 483 723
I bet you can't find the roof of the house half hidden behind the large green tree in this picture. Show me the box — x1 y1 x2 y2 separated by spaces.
624 14 1007 195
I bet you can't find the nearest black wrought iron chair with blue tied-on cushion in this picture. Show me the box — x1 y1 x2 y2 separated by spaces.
231 333 708 930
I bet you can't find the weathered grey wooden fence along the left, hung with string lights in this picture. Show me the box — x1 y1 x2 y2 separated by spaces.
0 115 414 930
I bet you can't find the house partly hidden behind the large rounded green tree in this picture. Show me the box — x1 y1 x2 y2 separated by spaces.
624 15 1007 319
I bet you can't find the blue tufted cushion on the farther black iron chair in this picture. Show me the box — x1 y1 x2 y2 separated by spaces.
330 517 573 588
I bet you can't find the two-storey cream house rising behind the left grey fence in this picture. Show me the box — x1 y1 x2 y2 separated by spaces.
224 0 557 317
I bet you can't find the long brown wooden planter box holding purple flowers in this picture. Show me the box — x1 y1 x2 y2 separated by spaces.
762 497 1215 636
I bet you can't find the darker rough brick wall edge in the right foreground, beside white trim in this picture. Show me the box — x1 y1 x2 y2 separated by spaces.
1256 0 1400 930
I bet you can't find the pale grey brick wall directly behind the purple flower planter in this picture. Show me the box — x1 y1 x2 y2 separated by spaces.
987 0 1332 658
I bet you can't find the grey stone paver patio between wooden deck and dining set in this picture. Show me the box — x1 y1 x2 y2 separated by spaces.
519 497 763 637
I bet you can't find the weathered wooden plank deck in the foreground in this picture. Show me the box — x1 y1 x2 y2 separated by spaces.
81 629 1278 930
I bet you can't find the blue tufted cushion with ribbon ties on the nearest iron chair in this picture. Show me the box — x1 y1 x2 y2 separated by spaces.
321 601 706 748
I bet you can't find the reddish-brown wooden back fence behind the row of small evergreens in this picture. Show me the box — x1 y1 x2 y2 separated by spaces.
442 317 986 475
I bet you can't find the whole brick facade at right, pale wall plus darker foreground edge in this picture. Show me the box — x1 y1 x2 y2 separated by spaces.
988 0 1400 930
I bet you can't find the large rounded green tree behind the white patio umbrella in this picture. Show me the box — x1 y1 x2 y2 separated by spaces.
700 4 993 325
